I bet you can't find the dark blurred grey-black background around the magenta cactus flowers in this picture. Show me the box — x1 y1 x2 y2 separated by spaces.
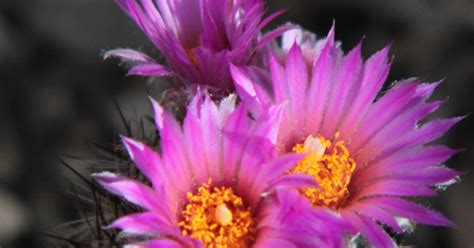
0 0 474 248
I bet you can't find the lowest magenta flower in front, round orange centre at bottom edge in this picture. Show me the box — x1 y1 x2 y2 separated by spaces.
93 94 343 247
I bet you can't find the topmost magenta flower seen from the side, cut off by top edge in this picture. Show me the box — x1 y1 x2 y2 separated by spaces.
104 0 289 90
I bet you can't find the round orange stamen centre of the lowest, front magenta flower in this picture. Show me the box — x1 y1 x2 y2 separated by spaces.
178 180 256 248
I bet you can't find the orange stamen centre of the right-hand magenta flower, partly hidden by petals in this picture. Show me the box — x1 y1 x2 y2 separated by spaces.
290 133 356 209
